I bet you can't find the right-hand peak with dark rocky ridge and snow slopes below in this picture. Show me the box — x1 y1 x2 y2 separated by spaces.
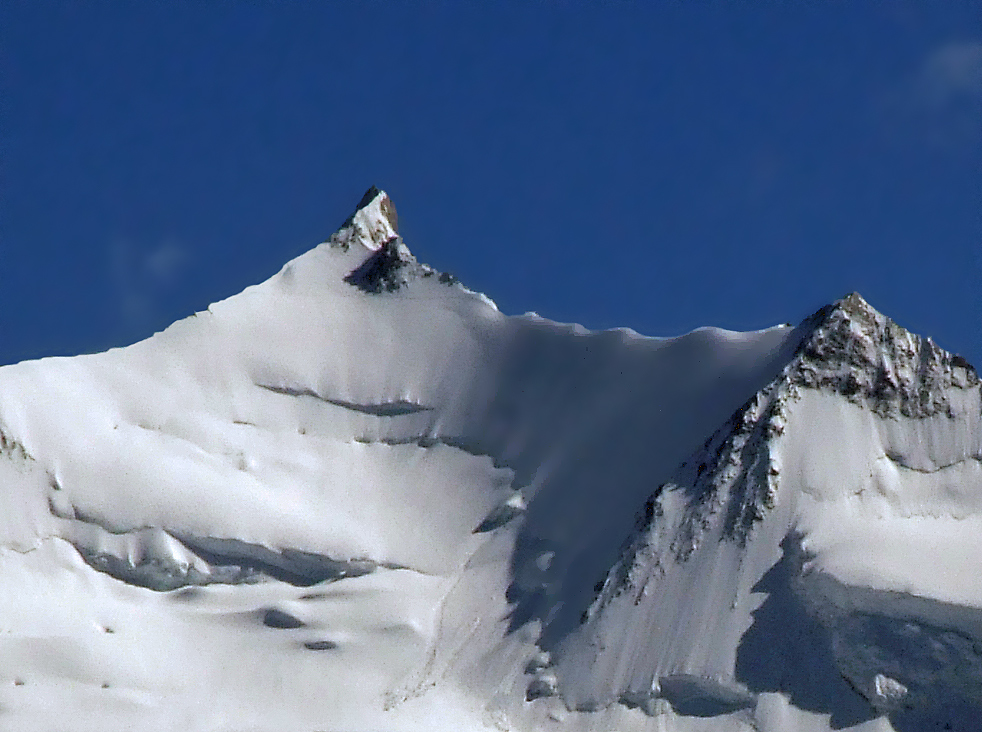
551 294 982 729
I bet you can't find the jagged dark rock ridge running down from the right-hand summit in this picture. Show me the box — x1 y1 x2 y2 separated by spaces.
604 292 980 576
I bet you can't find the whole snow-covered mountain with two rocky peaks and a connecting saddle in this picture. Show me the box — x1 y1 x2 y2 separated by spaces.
0 189 982 732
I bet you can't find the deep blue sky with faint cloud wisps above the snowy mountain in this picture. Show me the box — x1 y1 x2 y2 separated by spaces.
0 0 982 366
